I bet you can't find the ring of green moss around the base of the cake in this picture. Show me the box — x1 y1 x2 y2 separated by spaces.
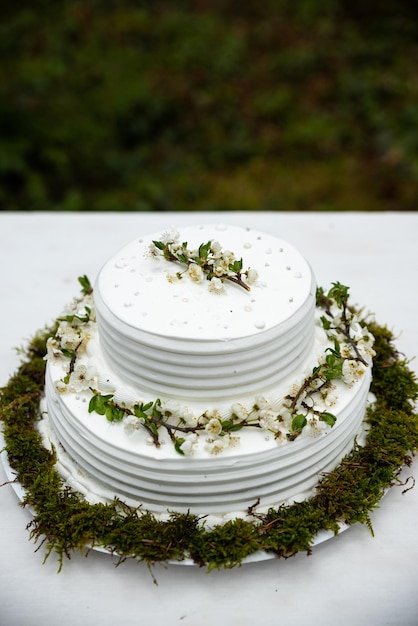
0 312 418 570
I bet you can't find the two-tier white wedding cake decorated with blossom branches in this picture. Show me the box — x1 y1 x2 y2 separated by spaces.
39 225 374 519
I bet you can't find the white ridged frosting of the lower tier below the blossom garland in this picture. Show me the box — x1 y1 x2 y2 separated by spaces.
44 354 371 514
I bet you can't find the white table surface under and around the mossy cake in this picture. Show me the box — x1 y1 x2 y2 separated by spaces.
0 212 418 626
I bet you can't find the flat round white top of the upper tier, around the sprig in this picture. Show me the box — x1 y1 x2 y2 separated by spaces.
96 224 314 341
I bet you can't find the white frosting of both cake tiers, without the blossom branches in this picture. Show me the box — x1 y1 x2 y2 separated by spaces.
42 226 371 515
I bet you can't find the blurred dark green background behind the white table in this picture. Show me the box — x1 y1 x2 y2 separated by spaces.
0 0 418 211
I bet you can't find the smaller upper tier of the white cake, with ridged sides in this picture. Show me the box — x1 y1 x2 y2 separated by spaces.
95 225 315 402
